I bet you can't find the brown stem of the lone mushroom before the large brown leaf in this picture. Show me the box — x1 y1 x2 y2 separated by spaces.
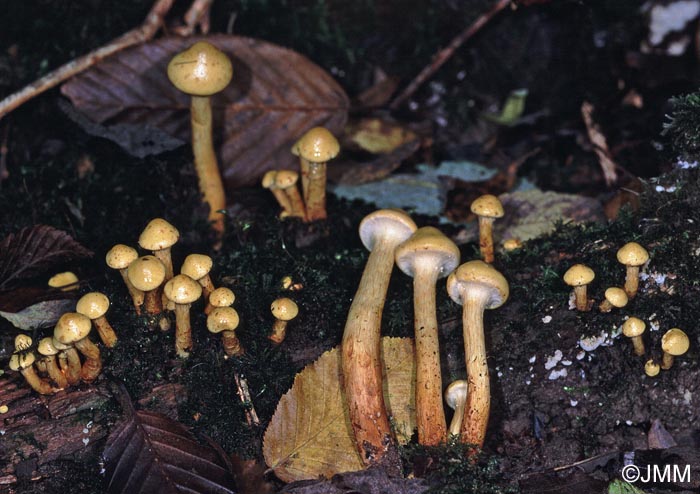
190 95 226 238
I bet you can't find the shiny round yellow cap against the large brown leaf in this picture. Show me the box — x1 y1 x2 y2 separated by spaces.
168 41 233 96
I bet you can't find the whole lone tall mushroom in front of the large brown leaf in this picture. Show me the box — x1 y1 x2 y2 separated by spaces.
168 41 233 237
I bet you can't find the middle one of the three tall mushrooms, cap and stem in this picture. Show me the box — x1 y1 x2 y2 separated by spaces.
395 226 459 446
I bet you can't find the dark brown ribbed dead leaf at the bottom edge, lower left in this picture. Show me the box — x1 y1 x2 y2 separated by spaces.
103 411 235 494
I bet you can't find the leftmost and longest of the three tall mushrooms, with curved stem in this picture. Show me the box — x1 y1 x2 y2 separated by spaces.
341 209 416 464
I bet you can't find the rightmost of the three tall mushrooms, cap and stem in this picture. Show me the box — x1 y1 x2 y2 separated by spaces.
447 261 510 448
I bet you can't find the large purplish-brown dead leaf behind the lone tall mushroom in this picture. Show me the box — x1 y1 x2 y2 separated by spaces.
62 35 348 188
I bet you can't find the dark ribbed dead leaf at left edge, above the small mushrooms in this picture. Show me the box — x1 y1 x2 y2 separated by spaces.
0 225 93 290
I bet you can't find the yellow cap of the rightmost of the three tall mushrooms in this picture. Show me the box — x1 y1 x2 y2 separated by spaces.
447 261 510 309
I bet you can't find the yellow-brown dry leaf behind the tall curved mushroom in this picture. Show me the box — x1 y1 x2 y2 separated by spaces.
263 337 416 482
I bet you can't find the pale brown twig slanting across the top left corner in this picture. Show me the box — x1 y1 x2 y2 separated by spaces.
0 0 173 118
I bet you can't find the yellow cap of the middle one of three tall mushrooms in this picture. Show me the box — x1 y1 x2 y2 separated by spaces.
396 226 460 278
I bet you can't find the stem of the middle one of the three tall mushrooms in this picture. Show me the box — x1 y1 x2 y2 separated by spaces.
413 263 447 446
